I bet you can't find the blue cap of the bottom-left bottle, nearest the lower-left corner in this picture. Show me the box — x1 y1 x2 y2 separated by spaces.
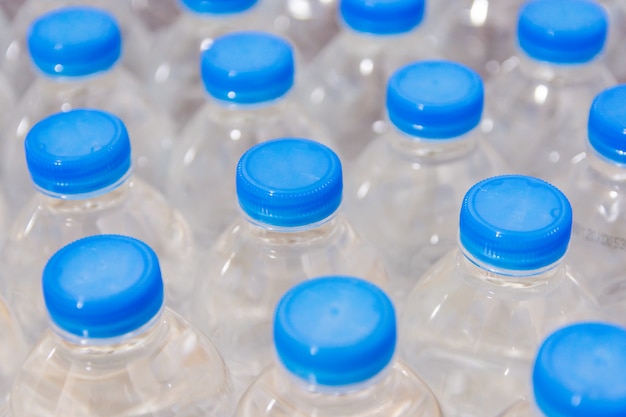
43 235 163 339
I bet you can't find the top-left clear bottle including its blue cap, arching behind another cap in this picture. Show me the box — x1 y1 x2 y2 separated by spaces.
2 6 174 214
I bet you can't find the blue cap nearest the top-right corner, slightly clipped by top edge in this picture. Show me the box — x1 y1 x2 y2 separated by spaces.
517 0 608 64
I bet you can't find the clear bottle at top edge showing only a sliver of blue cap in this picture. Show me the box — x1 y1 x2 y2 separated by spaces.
150 0 271 130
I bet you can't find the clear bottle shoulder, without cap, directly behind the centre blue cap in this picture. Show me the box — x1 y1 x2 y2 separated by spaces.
166 95 333 248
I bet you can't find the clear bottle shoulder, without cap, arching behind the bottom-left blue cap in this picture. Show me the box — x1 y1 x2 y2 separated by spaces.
1 177 198 346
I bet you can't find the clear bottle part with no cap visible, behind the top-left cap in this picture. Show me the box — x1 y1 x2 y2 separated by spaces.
2 0 151 95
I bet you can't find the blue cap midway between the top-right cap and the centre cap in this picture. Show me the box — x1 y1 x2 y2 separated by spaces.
387 61 484 139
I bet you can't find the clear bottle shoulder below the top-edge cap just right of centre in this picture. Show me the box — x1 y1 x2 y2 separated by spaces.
299 28 438 165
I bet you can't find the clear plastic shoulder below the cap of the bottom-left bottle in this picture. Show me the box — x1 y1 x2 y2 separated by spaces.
10 308 233 417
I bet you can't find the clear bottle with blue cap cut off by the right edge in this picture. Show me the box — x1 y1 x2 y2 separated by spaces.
561 85 626 324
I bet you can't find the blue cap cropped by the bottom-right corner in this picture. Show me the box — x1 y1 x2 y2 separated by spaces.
533 323 626 417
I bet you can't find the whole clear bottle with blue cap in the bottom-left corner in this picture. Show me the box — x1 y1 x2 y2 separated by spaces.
10 235 233 417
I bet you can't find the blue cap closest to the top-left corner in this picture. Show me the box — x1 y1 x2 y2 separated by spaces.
27 6 122 77
